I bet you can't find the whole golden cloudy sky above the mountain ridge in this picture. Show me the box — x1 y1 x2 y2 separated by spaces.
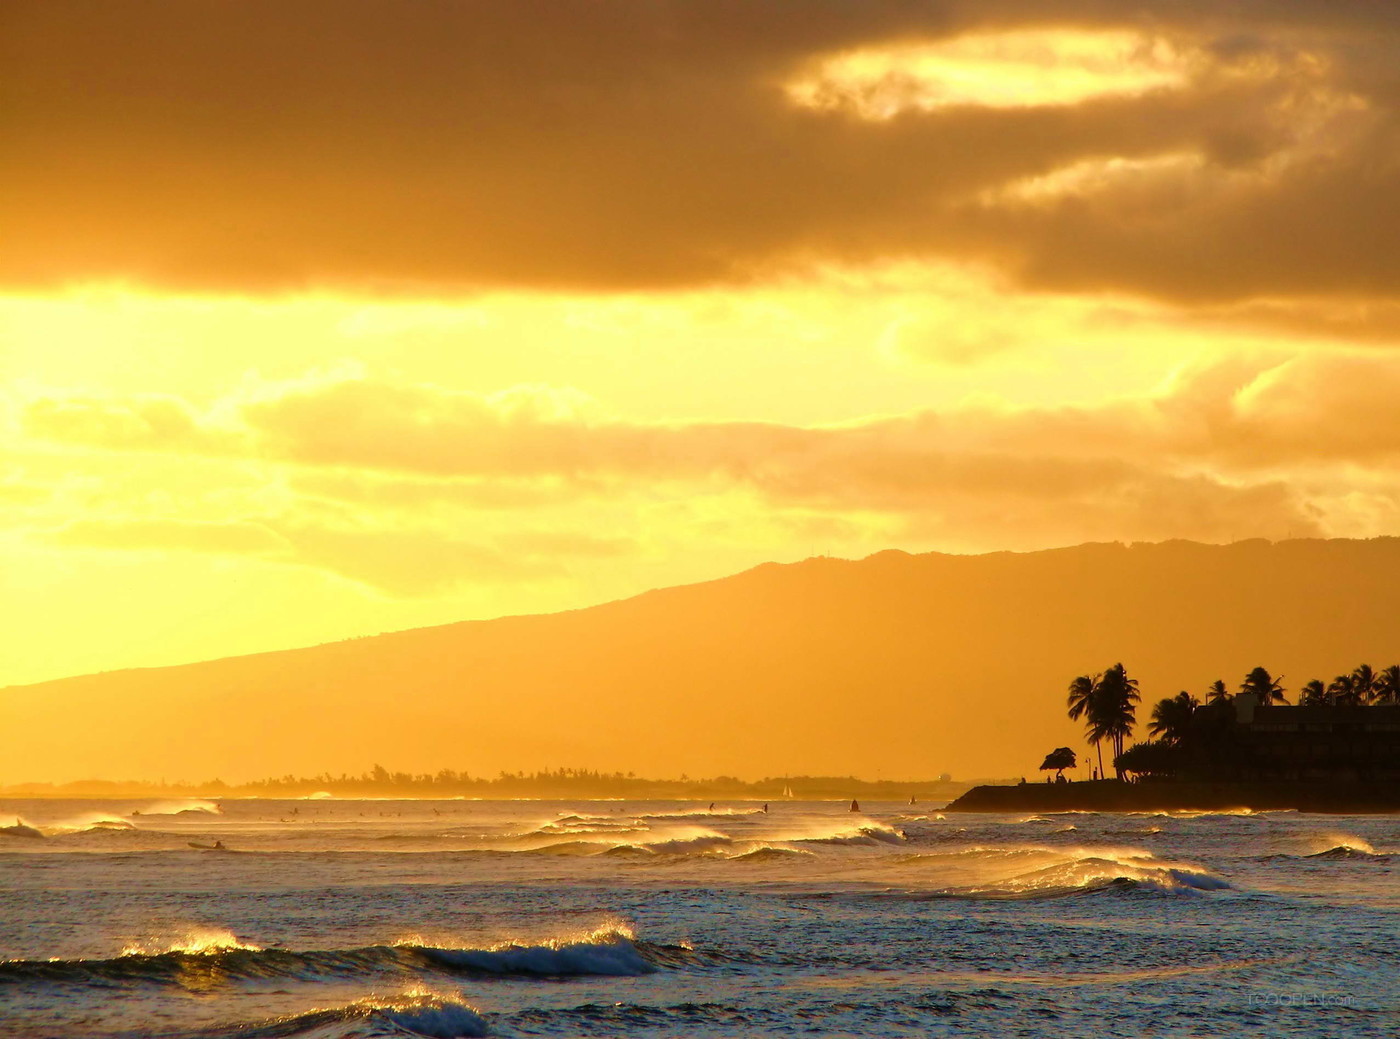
0 0 1400 694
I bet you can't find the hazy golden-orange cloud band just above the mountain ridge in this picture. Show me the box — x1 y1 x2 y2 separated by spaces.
11 347 1400 597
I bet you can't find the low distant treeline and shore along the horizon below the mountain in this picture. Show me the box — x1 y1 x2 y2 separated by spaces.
0 765 994 801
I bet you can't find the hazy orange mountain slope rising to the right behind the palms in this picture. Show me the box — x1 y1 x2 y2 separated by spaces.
8 538 1400 783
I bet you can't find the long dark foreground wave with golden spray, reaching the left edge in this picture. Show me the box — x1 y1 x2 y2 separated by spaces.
0 930 714 989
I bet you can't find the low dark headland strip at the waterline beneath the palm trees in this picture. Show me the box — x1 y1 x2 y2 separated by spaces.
944 780 1400 815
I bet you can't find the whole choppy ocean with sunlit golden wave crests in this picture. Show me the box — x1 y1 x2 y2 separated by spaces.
0 798 1400 1039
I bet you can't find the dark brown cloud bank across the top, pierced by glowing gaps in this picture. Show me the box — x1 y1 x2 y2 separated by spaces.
8 0 1400 302
